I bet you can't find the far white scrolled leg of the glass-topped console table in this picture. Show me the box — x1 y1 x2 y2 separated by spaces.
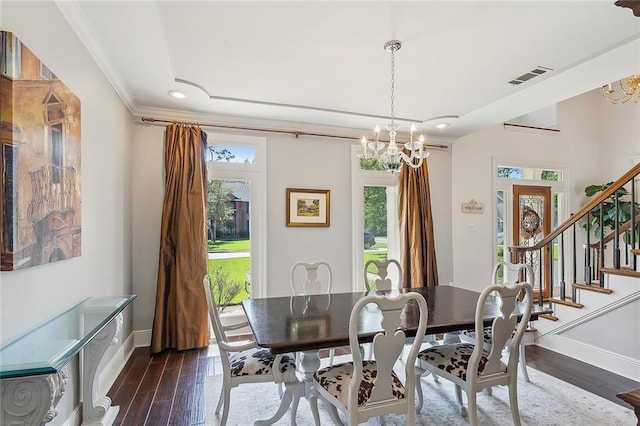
82 313 122 426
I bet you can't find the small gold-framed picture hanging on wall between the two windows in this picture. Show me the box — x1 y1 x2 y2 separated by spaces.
287 188 331 227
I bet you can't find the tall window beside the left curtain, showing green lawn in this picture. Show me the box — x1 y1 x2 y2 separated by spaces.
207 134 266 300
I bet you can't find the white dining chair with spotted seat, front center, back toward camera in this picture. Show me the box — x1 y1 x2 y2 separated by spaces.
309 292 428 425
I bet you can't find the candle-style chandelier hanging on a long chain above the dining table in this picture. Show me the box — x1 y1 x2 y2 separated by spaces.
358 40 429 173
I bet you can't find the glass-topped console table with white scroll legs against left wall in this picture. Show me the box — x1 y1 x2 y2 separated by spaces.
0 295 136 426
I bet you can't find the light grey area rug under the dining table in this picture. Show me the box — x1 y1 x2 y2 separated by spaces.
205 358 636 426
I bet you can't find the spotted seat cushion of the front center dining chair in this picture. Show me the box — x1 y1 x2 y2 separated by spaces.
313 361 404 406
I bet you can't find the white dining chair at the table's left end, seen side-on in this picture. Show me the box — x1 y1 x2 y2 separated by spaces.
203 275 301 426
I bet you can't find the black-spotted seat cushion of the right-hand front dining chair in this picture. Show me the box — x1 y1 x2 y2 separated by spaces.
418 343 507 380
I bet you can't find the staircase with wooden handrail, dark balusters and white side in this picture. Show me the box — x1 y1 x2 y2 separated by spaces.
509 164 640 381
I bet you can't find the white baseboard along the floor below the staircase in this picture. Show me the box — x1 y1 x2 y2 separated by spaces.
537 335 640 381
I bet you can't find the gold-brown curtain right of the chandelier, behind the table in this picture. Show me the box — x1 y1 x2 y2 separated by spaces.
398 160 438 288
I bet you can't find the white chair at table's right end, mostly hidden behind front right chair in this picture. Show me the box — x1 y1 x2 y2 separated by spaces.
459 261 535 382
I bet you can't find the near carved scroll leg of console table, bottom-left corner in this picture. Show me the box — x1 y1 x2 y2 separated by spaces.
0 366 69 426
